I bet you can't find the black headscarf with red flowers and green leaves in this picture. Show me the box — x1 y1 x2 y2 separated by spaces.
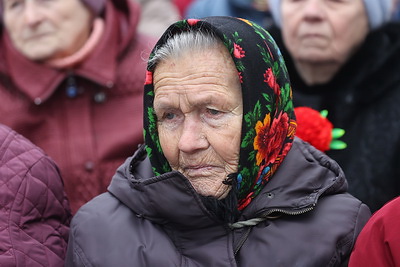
144 17 296 214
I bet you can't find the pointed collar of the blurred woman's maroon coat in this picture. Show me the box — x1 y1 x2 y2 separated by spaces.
1 1 139 103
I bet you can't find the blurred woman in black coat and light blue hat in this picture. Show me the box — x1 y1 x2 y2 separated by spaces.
269 0 400 214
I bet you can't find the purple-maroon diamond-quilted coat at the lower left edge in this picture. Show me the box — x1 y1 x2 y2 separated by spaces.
0 125 71 267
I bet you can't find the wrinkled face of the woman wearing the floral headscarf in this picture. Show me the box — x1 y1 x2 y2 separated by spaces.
154 45 243 198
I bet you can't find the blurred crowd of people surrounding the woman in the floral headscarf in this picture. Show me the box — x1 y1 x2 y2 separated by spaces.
0 0 400 266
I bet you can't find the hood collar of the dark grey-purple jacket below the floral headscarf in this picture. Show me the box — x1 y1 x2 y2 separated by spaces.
108 138 347 229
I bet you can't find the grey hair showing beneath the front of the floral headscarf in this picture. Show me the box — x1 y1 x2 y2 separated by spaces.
148 31 222 69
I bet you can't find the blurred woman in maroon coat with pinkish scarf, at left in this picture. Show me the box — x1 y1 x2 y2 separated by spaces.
0 0 154 212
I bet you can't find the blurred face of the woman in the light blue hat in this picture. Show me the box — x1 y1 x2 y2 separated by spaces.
281 0 368 64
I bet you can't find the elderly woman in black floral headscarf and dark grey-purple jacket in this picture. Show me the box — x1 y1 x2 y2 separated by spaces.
66 17 370 266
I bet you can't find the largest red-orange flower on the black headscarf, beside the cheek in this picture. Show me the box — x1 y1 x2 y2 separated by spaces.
253 112 289 166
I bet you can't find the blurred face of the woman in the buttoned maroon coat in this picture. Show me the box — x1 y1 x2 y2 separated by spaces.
2 0 92 61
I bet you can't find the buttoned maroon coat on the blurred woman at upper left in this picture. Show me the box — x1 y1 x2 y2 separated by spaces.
0 0 155 212
